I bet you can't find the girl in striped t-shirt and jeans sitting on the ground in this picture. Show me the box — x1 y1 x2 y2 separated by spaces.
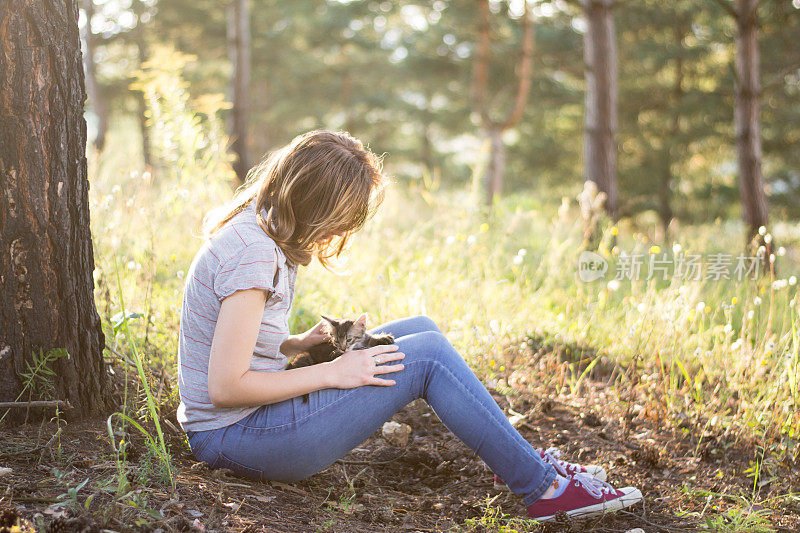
178 130 642 520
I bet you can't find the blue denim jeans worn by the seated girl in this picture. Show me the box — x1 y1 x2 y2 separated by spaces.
187 316 556 505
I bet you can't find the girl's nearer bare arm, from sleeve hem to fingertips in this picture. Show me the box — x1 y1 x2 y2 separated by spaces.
208 289 405 407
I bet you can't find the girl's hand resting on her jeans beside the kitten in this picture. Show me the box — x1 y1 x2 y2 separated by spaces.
322 344 406 389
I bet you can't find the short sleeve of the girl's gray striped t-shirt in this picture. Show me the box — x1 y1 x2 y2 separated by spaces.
214 246 282 301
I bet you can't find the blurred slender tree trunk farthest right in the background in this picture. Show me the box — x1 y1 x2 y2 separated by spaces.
734 0 769 248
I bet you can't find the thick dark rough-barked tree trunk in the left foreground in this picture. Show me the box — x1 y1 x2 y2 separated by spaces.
0 0 108 415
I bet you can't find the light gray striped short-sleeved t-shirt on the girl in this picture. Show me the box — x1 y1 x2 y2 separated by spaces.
178 205 297 431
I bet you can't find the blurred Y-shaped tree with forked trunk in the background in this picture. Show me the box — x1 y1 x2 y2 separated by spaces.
472 0 533 205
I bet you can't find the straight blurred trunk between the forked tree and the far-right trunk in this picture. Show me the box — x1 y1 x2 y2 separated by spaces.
583 0 618 219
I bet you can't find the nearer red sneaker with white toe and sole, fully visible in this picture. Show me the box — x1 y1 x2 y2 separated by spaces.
528 474 642 521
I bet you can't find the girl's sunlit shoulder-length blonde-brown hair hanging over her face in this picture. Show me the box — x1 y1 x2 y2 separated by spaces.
204 130 386 268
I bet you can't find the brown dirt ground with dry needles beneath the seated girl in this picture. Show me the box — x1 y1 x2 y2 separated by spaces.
0 372 800 533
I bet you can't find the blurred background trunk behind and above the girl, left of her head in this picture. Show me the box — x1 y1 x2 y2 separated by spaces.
228 0 250 182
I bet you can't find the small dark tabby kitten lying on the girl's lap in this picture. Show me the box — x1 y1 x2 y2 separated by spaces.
286 315 394 402
